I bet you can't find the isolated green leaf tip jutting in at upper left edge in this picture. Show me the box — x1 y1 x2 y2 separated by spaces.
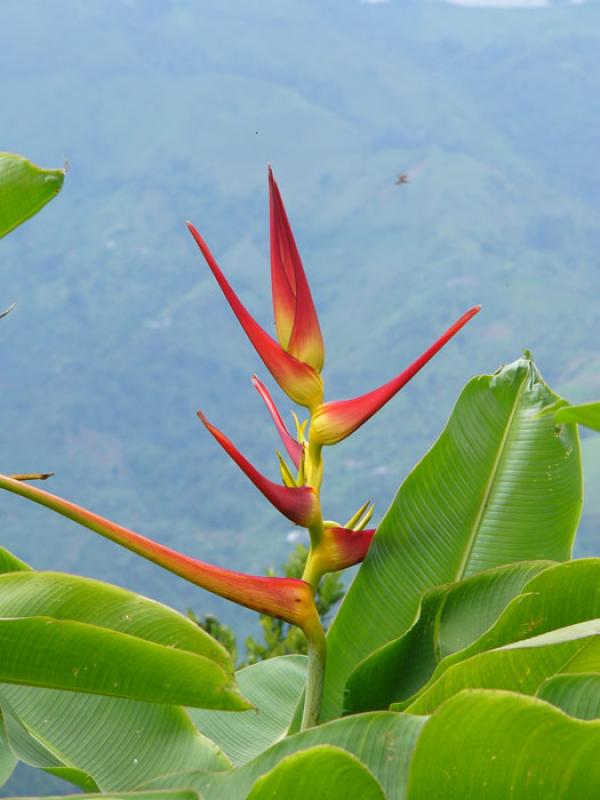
0 153 65 239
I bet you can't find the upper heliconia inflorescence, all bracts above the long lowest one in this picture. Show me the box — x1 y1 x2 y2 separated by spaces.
188 169 480 589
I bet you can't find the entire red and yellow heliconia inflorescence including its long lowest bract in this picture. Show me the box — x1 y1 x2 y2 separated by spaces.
0 169 479 676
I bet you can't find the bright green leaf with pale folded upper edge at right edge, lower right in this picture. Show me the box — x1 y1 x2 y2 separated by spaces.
400 619 600 714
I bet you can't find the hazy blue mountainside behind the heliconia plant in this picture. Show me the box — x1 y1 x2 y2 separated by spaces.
0 0 600 644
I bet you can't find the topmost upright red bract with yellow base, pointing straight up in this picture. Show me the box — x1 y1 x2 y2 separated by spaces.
269 167 325 372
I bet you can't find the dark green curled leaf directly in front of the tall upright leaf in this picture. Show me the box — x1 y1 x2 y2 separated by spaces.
344 561 552 713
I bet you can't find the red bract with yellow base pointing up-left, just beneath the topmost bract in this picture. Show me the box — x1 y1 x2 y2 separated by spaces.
188 222 323 409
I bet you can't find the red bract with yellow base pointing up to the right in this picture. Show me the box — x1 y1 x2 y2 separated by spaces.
310 306 481 445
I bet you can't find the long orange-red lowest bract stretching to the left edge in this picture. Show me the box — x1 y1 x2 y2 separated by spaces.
0 468 320 635
